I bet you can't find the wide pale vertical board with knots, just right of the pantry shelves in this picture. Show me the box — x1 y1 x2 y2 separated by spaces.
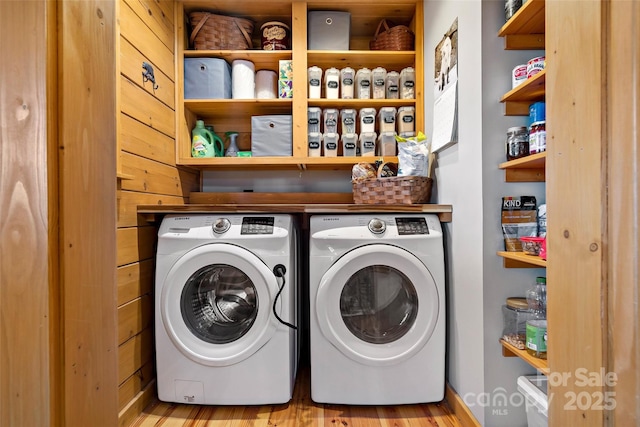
546 1 607 427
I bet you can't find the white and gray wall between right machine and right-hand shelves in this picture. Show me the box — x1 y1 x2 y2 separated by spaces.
425 0 544 427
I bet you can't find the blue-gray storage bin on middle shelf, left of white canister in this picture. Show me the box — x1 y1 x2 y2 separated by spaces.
184 58 231 99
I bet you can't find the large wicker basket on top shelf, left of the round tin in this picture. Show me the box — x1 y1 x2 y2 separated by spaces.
189 12 253 50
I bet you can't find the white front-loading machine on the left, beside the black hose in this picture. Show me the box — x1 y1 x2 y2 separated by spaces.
155 213 299 405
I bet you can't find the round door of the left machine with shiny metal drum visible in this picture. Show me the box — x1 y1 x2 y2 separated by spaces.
159 243 280 366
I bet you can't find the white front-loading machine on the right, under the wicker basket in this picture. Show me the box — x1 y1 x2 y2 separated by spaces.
309 214 445 405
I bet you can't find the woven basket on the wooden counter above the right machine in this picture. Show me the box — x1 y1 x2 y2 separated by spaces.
352 176 433 205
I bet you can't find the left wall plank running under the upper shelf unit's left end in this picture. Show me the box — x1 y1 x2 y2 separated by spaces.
122 153 200 196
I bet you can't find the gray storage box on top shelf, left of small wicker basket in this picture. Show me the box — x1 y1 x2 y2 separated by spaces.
307 10 351 50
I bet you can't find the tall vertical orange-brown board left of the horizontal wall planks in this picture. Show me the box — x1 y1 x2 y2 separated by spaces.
58 0 118 426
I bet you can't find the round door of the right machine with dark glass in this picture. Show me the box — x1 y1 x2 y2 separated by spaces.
316 244 439 366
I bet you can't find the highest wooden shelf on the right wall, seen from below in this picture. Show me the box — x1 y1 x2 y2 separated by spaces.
498 0 545 50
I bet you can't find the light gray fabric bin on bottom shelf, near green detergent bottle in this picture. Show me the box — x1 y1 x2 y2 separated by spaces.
251 115 293 157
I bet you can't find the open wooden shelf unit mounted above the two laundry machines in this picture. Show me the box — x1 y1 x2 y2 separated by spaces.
176 0 425 169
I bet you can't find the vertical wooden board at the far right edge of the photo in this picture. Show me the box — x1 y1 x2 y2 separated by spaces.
605 0 640 426
